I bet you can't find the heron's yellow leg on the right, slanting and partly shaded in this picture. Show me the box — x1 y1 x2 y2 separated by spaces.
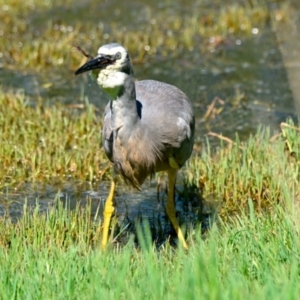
166 169 188 249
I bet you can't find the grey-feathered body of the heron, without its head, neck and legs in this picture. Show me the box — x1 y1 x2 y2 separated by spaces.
102 80 195 189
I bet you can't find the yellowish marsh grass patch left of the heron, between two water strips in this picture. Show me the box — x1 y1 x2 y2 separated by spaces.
0 91 107 187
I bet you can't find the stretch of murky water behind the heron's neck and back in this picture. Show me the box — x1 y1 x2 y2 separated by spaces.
0 30 296 143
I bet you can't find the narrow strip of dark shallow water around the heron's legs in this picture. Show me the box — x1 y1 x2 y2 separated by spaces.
0 180 210 247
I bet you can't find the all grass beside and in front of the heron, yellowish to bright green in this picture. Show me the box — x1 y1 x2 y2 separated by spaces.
0 88 300 299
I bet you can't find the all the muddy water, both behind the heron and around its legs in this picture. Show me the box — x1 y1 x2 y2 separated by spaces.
0 1 295 241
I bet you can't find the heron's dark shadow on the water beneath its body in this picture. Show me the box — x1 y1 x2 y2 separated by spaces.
105 178 217 249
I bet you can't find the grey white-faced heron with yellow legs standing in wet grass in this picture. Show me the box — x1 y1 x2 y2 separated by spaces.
75 43 195 248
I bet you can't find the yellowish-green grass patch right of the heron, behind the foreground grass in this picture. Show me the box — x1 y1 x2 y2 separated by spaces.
186 122 300 217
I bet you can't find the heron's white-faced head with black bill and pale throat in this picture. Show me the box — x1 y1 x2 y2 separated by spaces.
75 43 133 98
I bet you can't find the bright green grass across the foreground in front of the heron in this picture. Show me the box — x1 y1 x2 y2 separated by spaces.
0 199 300 299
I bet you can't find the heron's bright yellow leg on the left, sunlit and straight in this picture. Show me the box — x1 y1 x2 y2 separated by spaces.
101 179 116 250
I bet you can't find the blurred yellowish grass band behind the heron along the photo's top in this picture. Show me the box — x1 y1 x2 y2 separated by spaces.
0 0 288 71
